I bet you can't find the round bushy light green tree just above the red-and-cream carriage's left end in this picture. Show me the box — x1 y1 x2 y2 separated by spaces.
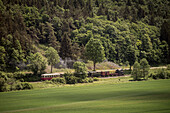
28 53 47 75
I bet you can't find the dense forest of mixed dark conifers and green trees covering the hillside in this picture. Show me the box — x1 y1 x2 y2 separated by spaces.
0 0 170 71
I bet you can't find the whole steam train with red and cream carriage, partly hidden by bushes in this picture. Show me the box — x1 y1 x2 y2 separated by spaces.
41 69 124 80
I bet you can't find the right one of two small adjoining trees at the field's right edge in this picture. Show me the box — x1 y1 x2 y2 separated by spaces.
140 58 150 79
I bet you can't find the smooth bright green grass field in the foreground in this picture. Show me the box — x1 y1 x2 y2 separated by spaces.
0 80 170 113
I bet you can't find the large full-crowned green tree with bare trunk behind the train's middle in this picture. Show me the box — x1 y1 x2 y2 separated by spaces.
85 38 105 70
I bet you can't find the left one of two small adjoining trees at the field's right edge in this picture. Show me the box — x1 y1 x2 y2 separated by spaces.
132 61 142 80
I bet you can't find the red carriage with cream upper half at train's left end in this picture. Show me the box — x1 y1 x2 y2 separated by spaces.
41 73 63 80
